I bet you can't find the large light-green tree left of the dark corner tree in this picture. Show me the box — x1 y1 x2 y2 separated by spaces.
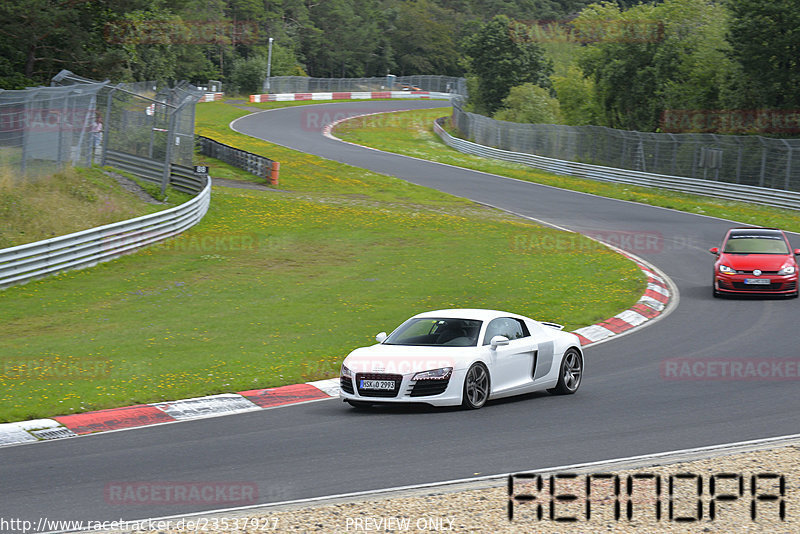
573 0 731 131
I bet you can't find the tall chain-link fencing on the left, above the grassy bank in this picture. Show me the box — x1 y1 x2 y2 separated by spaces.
0 71 204 181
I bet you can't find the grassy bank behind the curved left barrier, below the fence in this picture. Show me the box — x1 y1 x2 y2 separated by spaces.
0 168 175 248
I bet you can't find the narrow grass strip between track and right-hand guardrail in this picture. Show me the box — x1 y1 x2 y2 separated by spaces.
335 109 800 232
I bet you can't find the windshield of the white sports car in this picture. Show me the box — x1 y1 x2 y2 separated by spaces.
383 317 482 347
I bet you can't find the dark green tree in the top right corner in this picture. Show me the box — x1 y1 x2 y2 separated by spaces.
727 0 800 108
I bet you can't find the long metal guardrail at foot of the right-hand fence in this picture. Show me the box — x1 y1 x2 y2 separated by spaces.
433 118 800 210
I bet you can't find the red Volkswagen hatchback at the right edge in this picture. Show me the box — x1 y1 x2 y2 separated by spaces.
709 228 800 297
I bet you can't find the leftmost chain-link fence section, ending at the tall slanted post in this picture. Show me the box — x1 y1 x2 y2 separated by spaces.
0 81 107 176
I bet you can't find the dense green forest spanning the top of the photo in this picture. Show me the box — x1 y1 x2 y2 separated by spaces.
0 0 800 133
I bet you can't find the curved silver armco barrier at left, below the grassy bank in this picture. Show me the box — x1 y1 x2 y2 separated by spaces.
0 177 211 288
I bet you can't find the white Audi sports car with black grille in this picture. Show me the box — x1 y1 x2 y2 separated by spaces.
339 309 583 409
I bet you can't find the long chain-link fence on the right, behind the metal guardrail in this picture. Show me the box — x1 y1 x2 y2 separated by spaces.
453 101 800 191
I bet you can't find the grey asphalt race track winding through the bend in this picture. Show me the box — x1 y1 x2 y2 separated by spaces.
0 101 800 532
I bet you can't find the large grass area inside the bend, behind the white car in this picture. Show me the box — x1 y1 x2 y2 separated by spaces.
0 103 644 421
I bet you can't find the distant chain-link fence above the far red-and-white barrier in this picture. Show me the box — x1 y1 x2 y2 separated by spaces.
264 74 467 96
